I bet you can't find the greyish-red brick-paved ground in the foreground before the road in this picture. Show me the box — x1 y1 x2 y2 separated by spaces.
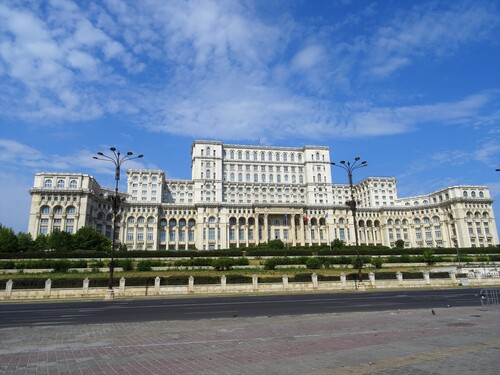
0 306 500 375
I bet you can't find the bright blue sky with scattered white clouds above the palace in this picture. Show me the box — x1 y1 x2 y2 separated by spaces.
0 0 500 232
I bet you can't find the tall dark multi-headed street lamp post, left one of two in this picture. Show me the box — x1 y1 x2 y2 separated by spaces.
93 147 144 299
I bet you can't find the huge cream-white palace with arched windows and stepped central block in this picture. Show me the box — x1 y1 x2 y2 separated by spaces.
28 141 498 250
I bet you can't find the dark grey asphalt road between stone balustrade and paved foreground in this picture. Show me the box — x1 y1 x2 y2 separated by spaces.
0 288 480 328
